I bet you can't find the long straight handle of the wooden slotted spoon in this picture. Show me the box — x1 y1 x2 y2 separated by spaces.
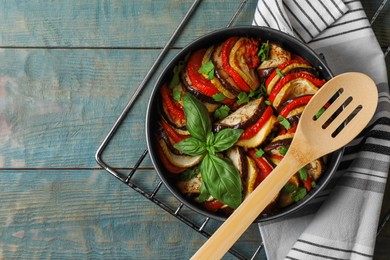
191 152 305 260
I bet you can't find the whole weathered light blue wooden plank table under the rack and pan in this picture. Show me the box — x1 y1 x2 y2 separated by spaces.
0 0 390 259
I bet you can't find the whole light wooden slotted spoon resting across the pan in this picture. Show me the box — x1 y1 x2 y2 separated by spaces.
191 72 378 260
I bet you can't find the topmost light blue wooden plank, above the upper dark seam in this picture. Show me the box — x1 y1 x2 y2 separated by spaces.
0 0 257 48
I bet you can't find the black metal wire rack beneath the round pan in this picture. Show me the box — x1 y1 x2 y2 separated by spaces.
95 0 390 259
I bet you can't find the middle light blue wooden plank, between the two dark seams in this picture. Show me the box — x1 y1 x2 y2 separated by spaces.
0 49 178 168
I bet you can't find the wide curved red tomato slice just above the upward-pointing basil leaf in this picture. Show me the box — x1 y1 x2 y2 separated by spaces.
187 49 220 97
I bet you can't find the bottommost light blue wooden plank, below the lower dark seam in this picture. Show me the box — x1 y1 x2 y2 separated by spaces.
0 170 266 259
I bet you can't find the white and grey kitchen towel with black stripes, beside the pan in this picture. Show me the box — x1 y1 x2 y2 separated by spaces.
253 0 390 260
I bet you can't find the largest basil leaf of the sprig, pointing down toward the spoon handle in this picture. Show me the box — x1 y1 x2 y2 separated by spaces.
200 154 242 209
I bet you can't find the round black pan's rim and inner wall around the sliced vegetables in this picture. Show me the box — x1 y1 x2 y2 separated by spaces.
146 26 343 222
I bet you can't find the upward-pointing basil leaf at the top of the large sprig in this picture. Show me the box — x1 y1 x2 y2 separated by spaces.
183 93 211 142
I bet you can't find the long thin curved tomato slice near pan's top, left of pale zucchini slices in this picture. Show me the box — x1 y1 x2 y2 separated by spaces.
221 37 251 92
